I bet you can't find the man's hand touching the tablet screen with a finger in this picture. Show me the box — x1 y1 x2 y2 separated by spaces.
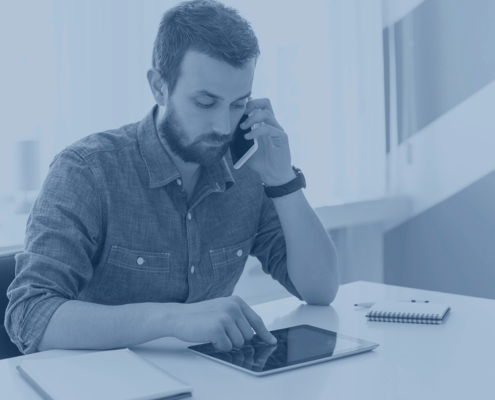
173 296 277 351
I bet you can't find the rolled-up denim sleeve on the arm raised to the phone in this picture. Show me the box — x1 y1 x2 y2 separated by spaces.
251 192 302 300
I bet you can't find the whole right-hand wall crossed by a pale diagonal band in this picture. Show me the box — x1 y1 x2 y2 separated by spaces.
384 0 495 297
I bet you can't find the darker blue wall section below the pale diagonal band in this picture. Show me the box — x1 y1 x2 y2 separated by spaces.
384 172 495 299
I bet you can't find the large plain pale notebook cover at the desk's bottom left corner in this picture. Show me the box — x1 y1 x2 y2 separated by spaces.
17 349 192 400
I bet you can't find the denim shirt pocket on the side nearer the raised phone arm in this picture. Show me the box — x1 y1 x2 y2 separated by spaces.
208 235 256 298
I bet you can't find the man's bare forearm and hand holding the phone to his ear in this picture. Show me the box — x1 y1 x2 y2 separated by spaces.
241 99 339 305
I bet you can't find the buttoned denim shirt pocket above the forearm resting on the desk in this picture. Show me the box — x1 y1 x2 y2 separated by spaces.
99 246 170 305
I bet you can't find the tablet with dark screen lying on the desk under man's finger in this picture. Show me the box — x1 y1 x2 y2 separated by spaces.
189 325 378 376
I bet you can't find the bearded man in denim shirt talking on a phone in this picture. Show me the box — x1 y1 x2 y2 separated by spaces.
5 0 338 353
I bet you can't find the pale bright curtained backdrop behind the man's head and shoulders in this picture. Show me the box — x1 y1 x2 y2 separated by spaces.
0 0 385 211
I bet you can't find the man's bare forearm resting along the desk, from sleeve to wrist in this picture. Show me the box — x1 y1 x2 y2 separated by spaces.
38 300 180 351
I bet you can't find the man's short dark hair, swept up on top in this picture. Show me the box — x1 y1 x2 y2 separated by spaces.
152 0 260 95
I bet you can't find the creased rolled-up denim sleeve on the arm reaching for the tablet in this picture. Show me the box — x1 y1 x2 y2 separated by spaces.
5 149 101 354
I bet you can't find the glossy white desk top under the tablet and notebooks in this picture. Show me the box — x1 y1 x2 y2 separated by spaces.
0 282 495 400
